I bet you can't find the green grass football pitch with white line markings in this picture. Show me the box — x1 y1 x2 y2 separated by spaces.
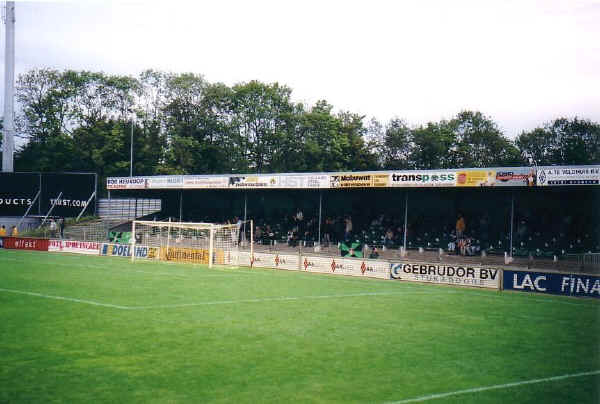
0 250 600 404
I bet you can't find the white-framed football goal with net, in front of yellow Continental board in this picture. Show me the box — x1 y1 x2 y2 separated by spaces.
131 220 253 268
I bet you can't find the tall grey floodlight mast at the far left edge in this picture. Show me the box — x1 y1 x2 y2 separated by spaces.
2 1 15 173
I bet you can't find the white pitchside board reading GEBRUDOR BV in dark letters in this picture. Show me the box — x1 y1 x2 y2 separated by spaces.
391 262 500 289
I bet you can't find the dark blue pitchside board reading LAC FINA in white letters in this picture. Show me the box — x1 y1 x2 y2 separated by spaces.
503 270 600 298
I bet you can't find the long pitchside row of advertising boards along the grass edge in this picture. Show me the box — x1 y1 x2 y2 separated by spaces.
0 237 600 299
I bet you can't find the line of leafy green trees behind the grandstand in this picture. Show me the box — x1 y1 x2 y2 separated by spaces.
5 68 600 188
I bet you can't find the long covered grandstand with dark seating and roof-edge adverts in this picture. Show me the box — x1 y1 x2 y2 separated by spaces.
107 166 600 269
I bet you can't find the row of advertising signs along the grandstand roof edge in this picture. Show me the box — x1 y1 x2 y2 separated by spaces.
106 166 600 190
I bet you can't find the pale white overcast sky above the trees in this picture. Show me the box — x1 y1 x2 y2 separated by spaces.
0 0 600 138
